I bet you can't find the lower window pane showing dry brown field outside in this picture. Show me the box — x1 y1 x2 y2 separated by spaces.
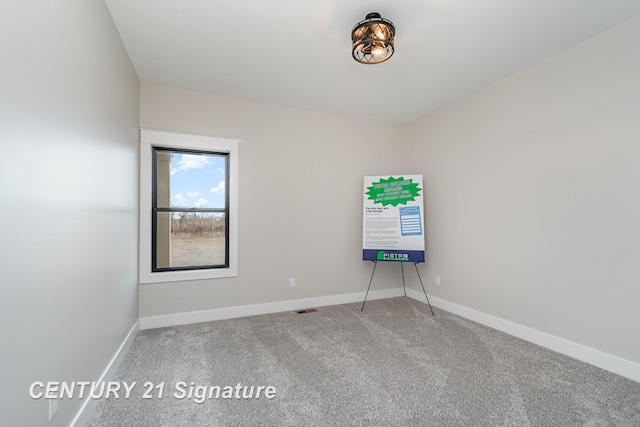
156 212 227 269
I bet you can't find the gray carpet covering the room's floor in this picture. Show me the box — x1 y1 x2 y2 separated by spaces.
89 298 640 426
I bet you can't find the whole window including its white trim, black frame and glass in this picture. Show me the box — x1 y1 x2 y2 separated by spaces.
140 130 238 283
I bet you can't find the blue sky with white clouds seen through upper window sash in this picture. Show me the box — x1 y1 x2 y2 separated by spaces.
171 153 225 208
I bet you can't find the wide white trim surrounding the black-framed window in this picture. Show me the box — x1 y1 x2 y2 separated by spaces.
139 129 240 284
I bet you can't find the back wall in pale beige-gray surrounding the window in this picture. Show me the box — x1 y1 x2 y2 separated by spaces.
140 83 409 317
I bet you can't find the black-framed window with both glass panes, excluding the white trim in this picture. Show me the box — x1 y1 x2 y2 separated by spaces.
151 147 229 272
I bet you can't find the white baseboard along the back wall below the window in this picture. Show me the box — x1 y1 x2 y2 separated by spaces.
140 288 404 329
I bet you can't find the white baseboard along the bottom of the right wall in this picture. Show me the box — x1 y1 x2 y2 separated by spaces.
407 289 640 382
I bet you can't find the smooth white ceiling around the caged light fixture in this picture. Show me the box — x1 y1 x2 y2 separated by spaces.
106 0 640 123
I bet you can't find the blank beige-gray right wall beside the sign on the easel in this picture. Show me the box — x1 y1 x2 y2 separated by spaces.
410 18 640 362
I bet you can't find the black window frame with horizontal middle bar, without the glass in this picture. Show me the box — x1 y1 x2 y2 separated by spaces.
151 145 230 273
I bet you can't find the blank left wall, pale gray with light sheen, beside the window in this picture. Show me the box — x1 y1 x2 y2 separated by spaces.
0 0 139 426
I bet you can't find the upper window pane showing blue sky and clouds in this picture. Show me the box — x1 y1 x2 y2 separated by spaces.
156 151 226 208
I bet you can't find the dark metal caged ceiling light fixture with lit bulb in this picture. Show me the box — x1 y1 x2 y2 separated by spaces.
351 12 396 64
